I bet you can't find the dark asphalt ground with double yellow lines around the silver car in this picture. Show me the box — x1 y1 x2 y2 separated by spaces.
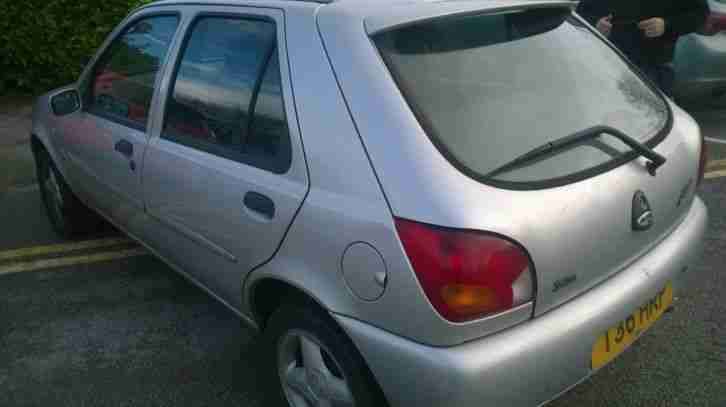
0 99 726 407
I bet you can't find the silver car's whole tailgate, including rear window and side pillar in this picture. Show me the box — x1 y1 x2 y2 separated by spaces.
319 0 701 345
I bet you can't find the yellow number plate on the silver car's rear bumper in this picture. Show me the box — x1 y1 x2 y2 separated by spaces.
592 282 673 369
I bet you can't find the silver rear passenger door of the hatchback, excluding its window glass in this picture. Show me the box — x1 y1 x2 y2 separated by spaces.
136 6 308 308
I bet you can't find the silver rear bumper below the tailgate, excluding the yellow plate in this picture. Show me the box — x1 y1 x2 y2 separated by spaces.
334 198 708 407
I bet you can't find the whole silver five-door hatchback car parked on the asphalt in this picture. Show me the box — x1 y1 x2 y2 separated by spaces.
32 0 707 407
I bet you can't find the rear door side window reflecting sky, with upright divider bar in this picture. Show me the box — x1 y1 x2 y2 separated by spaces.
162 17 290 173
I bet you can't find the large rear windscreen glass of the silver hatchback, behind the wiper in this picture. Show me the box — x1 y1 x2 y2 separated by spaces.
374 8 670 188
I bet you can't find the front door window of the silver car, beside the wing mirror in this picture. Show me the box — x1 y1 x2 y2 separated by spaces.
85 16 179 130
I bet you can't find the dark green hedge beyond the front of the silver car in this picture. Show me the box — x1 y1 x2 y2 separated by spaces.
0 0 150 94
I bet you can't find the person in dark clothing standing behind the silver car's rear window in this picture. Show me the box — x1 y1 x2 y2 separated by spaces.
577 0 708 96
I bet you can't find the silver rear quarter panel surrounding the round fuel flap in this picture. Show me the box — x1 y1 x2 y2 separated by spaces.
244 3 532 344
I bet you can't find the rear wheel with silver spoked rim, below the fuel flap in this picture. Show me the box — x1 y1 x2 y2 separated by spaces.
260 304 388 407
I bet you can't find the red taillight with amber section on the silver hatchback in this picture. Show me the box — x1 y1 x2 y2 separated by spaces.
396 219 535 322
